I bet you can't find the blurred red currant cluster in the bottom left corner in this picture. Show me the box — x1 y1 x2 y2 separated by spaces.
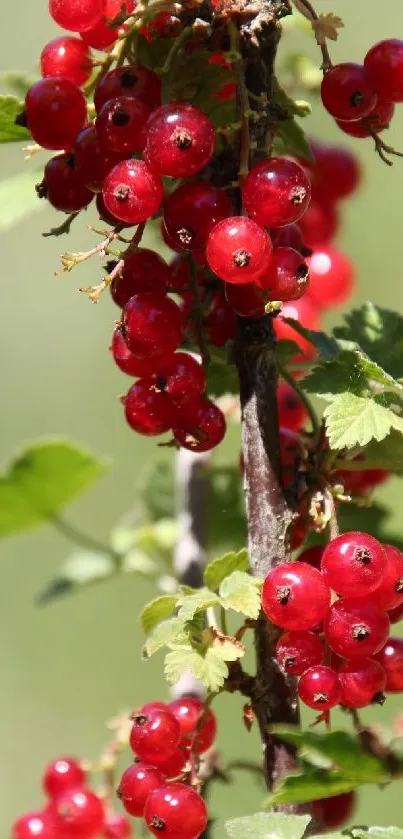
11 757 132 839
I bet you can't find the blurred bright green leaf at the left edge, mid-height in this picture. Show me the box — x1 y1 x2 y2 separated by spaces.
0 440 105 536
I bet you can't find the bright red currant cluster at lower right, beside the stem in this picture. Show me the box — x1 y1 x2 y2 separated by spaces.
262 532 403 712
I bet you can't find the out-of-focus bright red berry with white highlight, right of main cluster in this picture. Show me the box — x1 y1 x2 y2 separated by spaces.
307 245 354 309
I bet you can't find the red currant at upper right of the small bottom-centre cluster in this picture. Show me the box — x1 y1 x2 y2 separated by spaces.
169 696 217 754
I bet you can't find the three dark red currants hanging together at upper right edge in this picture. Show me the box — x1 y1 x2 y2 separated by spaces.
321 38 403 137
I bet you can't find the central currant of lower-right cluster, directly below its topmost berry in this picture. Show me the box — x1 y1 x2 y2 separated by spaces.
323 598 390 659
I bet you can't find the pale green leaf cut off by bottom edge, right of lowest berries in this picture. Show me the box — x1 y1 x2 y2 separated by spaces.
225 813 310 839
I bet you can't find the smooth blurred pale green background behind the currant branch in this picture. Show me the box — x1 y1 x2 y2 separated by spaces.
0 0 403 836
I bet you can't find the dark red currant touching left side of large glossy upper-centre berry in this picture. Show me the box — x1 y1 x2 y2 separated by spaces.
96 96 150 156
